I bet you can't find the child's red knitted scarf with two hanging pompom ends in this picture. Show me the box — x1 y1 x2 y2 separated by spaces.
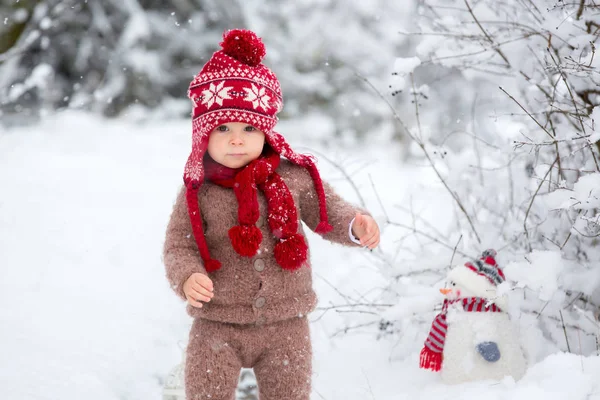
204 146 308 270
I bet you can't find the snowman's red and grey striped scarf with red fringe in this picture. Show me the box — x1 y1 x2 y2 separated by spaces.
419 297 502 371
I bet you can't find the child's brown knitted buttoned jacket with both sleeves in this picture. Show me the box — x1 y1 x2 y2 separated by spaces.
164 159 365 324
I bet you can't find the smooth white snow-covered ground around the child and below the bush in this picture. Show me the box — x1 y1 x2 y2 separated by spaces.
0 112 600 400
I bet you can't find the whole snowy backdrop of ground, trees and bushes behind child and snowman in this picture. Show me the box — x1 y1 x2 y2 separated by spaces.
0 0 600 400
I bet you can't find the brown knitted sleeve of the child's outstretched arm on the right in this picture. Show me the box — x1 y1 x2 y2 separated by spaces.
298 168 369 246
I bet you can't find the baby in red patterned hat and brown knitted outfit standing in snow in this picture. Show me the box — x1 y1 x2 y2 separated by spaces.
164 30 380 400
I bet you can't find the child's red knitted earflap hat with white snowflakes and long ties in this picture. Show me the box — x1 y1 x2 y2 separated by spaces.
183 29 332 272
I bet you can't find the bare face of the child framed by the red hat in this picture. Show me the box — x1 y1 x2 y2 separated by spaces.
207 122 265 168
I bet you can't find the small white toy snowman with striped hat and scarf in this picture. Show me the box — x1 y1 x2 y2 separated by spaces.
420 250 526 384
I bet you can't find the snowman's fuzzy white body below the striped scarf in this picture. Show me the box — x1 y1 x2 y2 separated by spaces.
441 302 526 384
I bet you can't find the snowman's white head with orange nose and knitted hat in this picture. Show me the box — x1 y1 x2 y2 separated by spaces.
440 249 506 308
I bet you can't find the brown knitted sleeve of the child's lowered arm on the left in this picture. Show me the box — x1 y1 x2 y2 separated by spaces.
163 187 206 300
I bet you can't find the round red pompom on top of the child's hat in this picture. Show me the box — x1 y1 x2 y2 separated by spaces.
221 29 267 67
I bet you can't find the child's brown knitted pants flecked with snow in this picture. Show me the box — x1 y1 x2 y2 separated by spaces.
185 317 312 400
